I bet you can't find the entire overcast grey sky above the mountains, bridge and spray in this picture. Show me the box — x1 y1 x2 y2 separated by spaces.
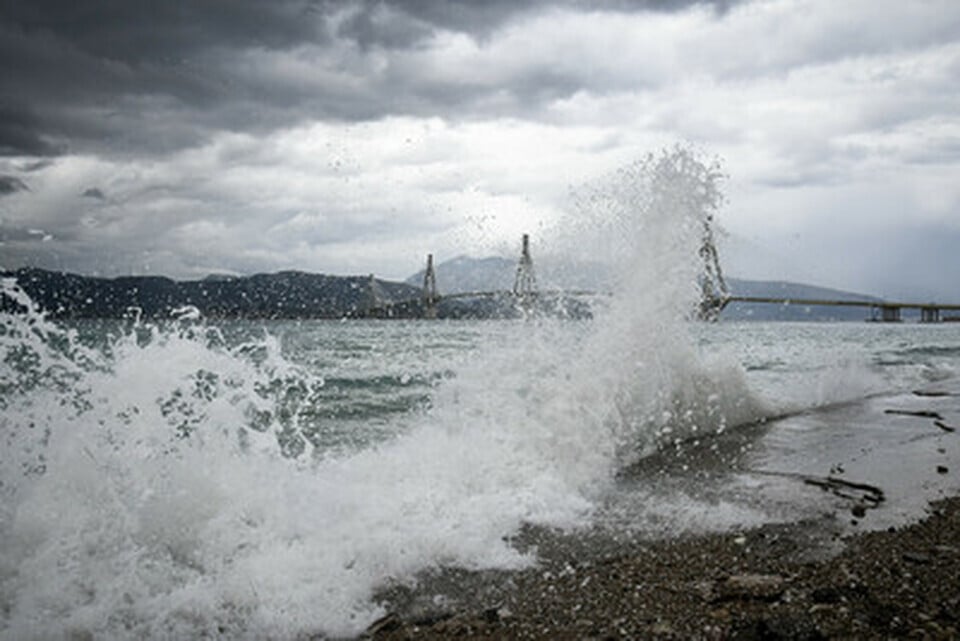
0 0 960 301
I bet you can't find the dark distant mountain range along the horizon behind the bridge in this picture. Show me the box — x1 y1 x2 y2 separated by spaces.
0 256 880 321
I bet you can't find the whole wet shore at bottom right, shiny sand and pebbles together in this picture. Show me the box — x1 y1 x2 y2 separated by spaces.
366 382 960 640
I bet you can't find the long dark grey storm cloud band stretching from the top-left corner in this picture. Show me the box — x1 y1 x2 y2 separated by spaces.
0 0 744 156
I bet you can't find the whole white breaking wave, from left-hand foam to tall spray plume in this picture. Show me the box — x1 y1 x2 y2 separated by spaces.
0 149 757 639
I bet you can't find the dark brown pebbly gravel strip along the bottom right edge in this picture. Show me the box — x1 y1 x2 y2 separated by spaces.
366 498 960 640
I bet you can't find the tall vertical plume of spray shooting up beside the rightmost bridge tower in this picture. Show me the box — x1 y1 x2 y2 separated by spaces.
569 147 765 463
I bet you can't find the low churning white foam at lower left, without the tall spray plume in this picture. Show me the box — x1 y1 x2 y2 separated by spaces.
2 304 590 638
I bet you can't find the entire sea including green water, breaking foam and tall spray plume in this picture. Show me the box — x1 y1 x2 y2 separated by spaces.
0 152 960 639
